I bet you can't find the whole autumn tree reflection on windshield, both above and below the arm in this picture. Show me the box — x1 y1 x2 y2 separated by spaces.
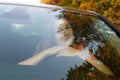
55 11 120 80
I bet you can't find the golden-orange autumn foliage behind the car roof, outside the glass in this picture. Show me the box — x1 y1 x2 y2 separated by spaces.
42 0 120 29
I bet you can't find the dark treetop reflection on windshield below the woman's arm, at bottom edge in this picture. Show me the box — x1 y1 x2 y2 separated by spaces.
63 62 116 80
